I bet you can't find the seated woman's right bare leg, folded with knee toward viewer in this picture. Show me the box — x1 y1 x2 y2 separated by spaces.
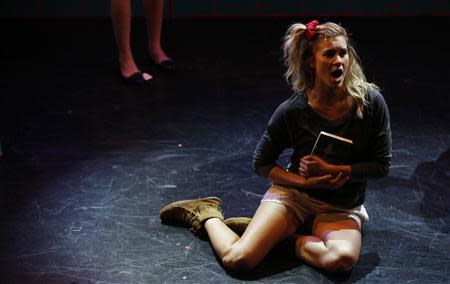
296 214 361 271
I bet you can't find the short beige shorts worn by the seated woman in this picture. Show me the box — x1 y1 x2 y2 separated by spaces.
261 184 369 228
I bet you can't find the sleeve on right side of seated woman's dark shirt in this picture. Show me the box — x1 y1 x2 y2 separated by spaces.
351 90 392 180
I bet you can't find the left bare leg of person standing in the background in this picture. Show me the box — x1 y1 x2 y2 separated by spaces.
111 0 152 80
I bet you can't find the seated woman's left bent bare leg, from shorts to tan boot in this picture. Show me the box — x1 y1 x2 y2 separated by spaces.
205 202 299 270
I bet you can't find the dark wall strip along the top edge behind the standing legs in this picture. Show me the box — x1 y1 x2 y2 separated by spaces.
0 0 450 19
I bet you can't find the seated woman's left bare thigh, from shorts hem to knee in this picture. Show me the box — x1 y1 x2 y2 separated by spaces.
233 202 299 266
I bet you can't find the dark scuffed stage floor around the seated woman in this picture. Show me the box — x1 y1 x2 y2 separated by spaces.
0 18 450 283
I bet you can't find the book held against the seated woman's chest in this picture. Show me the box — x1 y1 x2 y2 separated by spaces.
311 131 353 165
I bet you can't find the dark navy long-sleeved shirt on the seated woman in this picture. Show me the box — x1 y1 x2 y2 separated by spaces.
253 89 392 208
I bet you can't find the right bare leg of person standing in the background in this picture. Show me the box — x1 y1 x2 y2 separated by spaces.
143 0 170 63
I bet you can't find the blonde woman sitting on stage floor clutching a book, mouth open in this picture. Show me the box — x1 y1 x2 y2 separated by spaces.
160 21 391 271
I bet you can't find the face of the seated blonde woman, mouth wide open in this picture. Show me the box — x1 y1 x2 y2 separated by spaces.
311 36 349 88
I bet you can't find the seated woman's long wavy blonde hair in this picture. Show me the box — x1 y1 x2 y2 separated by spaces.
283 22 378 118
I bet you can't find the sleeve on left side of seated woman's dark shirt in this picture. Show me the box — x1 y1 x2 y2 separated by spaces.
253 105 290 177
